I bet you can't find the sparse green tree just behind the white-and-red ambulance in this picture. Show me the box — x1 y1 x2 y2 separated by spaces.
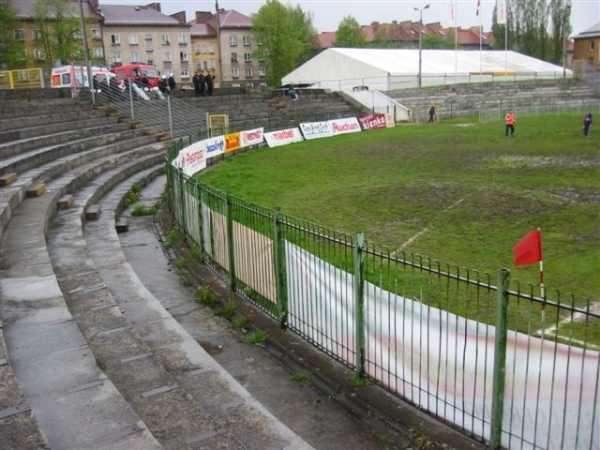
33 0 85 67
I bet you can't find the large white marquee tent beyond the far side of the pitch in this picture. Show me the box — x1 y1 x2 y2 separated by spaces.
282 48 572 91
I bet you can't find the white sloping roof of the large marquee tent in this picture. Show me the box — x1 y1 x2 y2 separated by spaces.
282 48 563 84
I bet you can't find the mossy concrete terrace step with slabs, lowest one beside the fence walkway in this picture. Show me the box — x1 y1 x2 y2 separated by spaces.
43 171 310 449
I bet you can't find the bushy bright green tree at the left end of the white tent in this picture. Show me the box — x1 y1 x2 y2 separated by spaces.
252 0 314 86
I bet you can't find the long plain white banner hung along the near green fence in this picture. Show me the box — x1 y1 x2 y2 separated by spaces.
286 242 600 450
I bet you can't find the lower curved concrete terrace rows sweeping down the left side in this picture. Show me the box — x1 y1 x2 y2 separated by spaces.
0 96 311 449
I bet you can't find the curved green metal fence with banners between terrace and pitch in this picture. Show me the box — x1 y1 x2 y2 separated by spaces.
167 142 600 449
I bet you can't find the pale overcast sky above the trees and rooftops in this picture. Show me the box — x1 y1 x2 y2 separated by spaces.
105 0 600 35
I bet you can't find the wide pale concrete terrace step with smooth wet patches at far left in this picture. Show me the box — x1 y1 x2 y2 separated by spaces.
0 157 169 449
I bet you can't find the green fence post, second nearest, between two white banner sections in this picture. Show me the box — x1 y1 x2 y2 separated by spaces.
354 231 365 377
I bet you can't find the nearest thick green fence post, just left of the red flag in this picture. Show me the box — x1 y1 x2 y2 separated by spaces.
490 269 510 450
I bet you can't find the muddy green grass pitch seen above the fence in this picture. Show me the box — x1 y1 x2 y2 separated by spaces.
201 111 600 304
